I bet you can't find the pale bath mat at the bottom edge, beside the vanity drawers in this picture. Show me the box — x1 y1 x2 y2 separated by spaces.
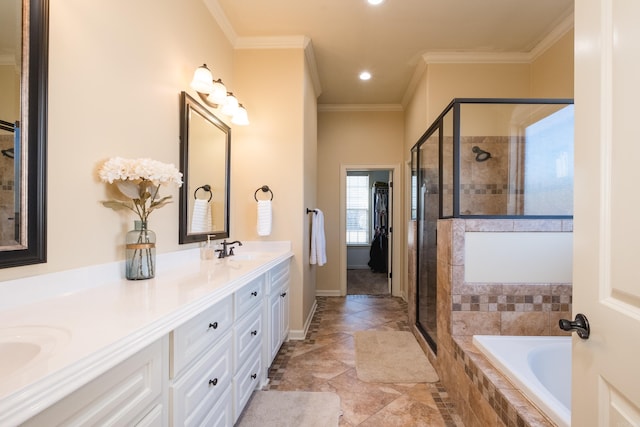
236 391 342 427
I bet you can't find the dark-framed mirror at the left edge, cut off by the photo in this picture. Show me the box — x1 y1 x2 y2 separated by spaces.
0 0 49 268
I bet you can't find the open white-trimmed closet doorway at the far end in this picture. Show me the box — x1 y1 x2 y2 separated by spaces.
341 166 395 295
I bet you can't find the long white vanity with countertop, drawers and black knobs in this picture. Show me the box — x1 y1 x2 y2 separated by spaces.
0 242 292 426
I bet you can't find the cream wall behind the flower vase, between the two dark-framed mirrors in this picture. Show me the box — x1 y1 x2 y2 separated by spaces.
0 0 234 280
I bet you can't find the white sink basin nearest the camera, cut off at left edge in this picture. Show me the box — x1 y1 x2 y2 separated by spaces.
0 326 70 378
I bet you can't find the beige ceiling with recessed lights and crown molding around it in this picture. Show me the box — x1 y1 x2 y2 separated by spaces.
210 0 574 105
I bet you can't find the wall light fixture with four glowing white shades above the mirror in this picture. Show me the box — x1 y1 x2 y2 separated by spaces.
191 64 249 125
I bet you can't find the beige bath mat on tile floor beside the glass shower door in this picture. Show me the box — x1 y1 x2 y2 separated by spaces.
354 331 438 383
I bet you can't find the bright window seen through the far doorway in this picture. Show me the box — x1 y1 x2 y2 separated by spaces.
347 175 370 245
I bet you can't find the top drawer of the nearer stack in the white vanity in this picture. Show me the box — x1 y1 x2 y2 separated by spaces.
169 295 233 378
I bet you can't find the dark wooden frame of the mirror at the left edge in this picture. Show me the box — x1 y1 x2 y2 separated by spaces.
0 0 49 268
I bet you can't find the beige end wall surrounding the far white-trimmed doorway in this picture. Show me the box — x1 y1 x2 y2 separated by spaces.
317 111 404 294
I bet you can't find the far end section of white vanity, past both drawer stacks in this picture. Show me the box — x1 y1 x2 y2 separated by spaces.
265 260 289 369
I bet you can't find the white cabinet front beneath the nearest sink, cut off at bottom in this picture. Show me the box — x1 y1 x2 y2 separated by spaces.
22 337 169 427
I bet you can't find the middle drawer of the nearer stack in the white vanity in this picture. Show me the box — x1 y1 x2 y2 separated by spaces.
170 332 233 426
